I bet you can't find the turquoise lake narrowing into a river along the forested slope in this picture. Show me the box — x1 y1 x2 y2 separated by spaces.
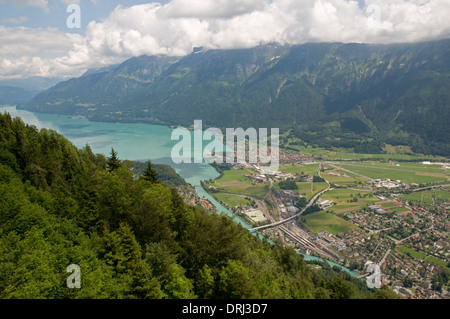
0 106 359 277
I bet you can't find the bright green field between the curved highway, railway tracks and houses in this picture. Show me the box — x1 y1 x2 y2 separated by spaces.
302 211 357 235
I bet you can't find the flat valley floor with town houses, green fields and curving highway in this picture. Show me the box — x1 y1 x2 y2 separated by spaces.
203 150 450 299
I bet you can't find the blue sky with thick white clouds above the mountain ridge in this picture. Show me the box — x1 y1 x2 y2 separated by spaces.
0 0 450 80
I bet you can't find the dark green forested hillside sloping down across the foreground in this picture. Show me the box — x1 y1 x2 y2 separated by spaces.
0 115 398 298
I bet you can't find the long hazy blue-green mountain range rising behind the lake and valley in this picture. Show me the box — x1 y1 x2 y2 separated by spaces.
22 40 450 156
